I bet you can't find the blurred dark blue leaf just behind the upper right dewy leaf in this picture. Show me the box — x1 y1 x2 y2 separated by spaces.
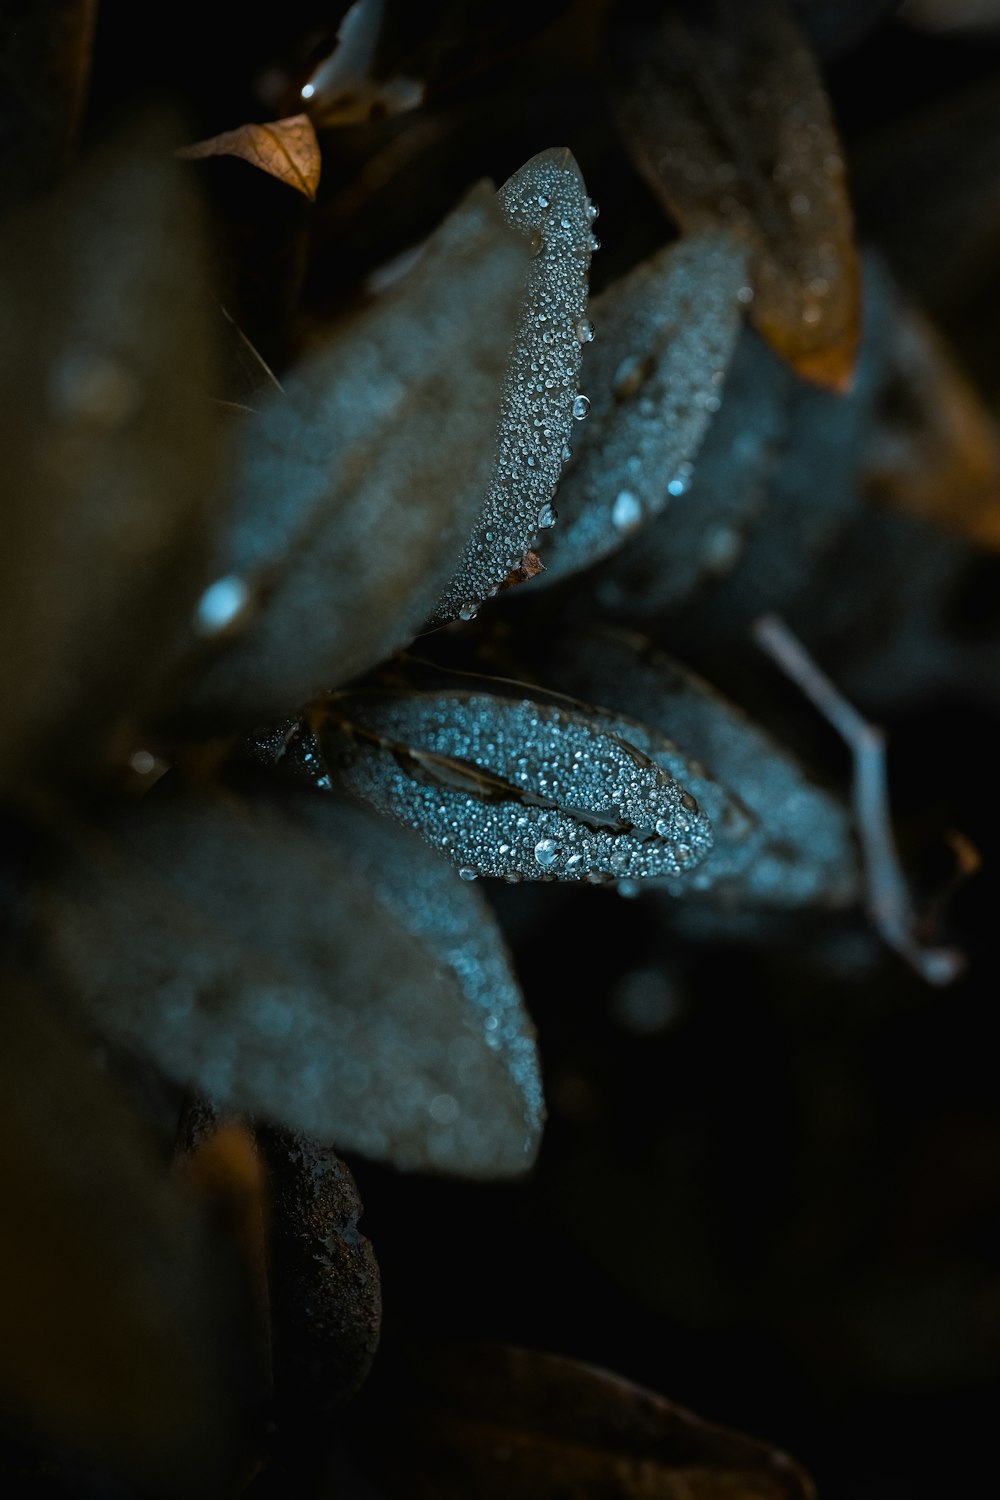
595 327 793 623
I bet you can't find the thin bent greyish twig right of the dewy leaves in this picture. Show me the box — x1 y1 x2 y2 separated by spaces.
753 615 966 984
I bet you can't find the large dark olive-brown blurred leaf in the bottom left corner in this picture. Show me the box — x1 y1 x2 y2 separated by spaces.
0 986 244 1494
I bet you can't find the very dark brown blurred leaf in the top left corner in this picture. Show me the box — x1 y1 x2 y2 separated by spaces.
0 0 97 216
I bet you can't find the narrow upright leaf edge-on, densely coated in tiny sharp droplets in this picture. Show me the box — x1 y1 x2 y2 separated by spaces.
430 149 592 624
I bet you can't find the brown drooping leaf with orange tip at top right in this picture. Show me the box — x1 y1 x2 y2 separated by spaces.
615 0 861 390
